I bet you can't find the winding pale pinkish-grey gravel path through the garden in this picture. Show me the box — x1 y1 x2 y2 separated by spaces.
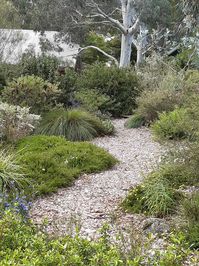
31 119 162 237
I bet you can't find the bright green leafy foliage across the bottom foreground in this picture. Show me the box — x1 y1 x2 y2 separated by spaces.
0 211 190 266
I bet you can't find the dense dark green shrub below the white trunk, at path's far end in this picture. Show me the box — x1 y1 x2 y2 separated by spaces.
76 64 139 117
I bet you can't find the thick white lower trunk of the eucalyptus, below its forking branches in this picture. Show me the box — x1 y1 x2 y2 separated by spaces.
120 34 132 68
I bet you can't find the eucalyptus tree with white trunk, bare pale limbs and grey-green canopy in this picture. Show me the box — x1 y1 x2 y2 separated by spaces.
12 0 176 67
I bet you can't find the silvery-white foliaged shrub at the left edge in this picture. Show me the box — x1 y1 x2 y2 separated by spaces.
0 102 40 141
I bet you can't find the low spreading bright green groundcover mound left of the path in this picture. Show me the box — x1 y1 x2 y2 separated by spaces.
17 136 116 196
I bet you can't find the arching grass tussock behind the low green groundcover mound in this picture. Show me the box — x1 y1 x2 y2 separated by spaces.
36 109 111 141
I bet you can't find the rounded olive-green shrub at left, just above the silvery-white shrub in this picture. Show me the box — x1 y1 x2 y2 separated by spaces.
2 76 60 113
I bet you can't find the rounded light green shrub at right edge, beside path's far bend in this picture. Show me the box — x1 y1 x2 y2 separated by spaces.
151 108 193 140
